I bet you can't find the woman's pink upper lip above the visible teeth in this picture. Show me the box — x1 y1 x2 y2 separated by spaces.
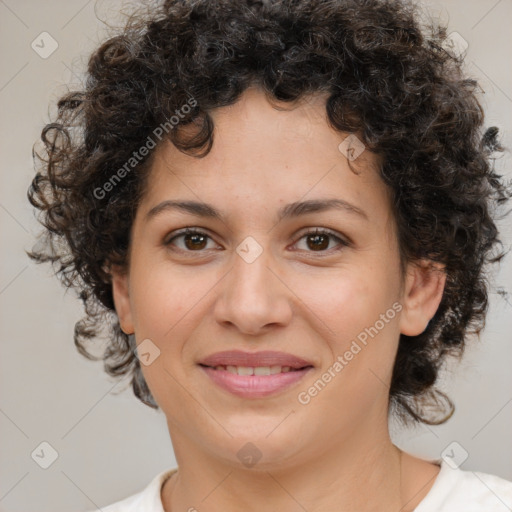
199 350 313 368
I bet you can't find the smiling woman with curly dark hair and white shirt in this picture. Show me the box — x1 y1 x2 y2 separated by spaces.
29 0 512 512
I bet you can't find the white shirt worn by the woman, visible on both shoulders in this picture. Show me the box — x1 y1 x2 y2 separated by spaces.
91 460 512 512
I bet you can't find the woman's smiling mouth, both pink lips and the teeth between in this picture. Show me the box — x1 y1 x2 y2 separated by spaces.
199 351 314 399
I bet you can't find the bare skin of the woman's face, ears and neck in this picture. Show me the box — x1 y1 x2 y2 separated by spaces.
112 87 445 512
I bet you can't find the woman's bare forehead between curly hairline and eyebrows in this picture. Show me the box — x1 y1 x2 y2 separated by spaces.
136 88 389 226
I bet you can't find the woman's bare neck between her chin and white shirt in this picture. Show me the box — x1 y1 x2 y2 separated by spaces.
162 422 412 512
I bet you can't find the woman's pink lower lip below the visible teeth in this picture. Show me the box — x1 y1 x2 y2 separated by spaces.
201 366 313 398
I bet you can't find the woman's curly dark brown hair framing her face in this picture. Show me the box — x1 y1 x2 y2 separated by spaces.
28 0 510 424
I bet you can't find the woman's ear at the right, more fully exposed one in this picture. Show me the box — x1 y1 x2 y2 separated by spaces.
400 260 446 336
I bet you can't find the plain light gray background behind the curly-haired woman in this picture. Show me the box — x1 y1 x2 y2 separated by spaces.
0 0 512 512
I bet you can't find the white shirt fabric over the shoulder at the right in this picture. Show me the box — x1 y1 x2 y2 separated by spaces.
414 460 512 512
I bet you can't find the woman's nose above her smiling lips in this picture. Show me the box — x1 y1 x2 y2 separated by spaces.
214 243 292 335
